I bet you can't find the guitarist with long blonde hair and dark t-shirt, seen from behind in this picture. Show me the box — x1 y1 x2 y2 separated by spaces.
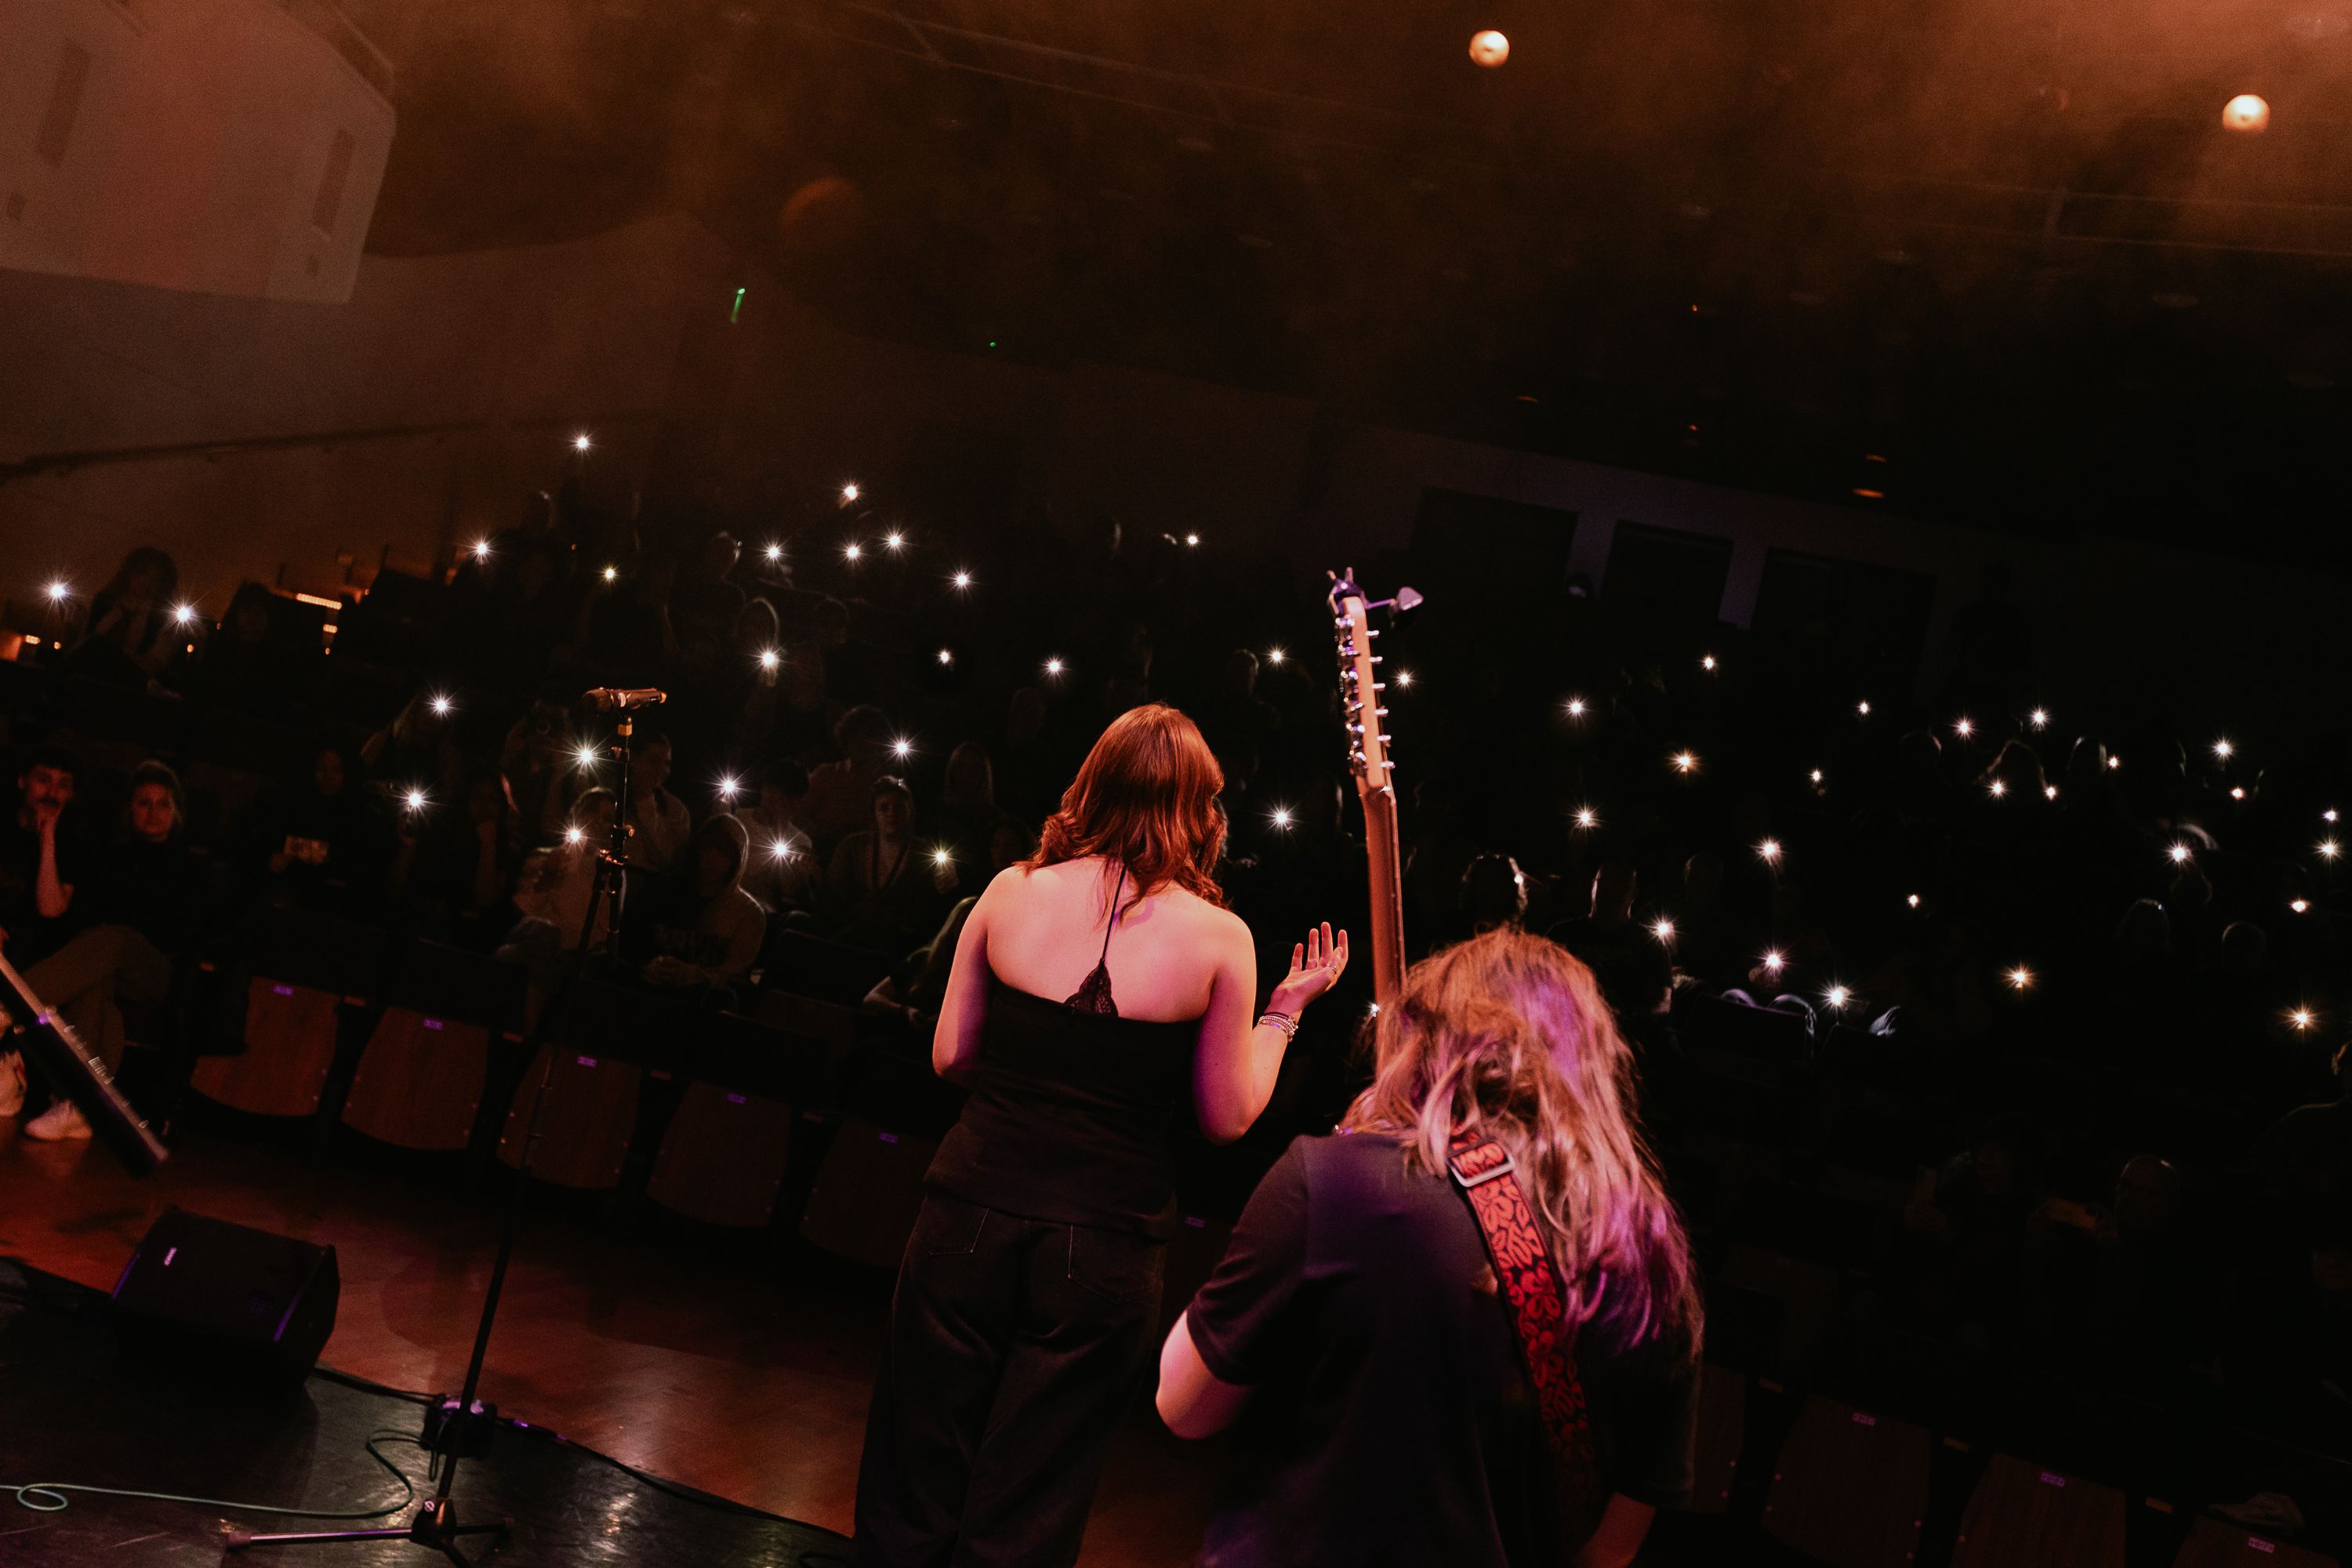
1157 928 1700 1568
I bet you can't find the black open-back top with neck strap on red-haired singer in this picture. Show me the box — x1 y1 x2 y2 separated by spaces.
924 867 1200 1241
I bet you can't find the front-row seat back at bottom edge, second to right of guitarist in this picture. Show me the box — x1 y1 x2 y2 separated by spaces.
1762 1394 1929 1568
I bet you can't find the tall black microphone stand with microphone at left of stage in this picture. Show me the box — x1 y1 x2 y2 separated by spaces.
223 691 663 1568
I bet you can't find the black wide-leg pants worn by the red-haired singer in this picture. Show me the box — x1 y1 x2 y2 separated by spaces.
856 1194 1167 1568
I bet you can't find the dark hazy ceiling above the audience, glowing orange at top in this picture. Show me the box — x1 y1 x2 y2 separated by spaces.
346 0 2352 567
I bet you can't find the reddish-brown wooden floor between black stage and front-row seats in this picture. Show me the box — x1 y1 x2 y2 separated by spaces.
0 1121 1221 1568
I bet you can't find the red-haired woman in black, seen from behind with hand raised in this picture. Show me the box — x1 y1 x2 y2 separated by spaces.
856 706 1348 1568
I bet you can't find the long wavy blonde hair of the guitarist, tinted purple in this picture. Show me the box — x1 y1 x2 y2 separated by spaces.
1341 928 1700 1354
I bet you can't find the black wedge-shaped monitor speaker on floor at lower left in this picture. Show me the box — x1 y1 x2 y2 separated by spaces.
115 1208 341 1382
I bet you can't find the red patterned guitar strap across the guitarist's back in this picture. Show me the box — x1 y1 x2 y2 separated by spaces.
1454 1138 1602 1519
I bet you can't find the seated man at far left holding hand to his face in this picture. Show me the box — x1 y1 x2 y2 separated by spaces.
0 748 172 1142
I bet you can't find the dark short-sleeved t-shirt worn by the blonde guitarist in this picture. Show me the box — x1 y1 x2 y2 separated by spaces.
1190 1133 1698 1568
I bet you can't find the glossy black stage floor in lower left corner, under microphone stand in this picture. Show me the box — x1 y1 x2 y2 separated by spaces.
0 1260 849 1568
